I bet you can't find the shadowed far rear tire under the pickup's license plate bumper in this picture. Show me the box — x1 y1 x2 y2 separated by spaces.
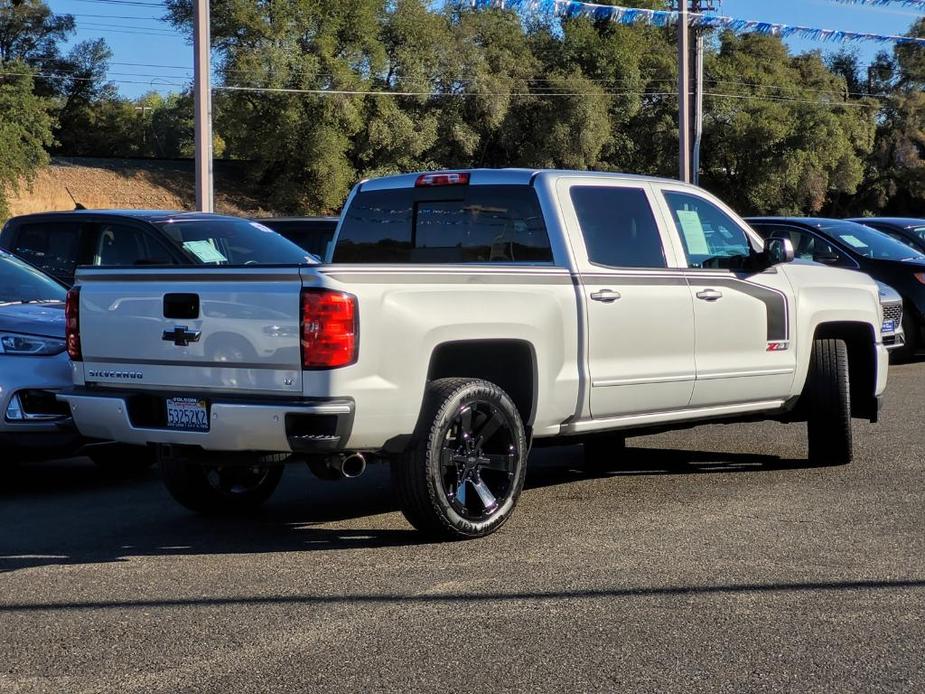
158 448 287 514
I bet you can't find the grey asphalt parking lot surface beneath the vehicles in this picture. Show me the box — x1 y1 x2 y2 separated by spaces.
0 362 925 692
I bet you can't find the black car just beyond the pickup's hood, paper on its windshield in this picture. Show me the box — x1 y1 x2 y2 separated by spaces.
746 217 925 359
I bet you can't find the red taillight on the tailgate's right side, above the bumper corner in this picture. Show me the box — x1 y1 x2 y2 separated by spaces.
302 289 359 369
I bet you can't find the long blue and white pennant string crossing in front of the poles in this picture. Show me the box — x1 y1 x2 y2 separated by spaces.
472 0 925 46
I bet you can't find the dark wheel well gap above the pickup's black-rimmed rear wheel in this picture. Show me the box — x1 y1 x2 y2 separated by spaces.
427 340 536 427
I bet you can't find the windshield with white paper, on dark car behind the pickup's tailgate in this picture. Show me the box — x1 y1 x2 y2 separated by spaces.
155 219 318 265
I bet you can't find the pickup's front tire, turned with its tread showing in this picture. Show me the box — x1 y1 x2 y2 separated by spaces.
806 339 852 465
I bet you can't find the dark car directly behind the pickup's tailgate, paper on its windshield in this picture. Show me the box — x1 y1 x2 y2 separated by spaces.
0 210 317 286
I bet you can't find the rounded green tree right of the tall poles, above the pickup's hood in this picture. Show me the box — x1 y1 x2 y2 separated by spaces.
703 33 876 214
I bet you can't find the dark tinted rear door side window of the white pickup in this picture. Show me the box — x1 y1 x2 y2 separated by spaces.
570 186 667 268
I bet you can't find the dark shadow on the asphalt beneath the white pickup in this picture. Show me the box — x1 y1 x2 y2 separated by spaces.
0 446 808 573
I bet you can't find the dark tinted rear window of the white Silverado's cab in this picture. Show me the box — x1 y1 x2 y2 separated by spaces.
333 185 553 264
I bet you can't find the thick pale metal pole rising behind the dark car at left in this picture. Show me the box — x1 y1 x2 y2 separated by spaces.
193 0 214 212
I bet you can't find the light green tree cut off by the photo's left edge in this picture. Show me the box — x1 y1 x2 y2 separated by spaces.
0 61 52 219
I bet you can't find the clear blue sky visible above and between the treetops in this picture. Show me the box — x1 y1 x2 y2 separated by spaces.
48 0 921 97
